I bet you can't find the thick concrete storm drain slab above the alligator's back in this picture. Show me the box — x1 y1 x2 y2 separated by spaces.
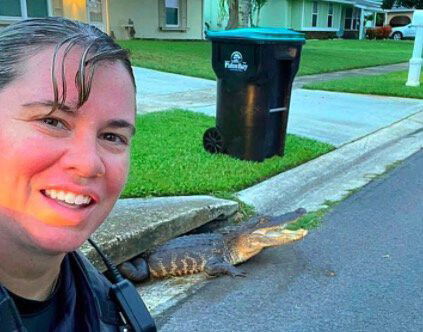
81 196 238 271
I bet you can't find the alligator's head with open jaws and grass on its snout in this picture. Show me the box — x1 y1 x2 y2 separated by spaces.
226 208 307 264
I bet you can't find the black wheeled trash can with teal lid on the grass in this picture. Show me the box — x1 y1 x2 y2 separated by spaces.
203 28 305 161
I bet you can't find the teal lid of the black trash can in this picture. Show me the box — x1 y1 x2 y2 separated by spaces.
205 28 305 43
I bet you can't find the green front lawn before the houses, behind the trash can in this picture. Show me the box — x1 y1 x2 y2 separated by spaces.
119 40 413 79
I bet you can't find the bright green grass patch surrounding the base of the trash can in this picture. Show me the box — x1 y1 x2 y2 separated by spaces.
122 110 333 197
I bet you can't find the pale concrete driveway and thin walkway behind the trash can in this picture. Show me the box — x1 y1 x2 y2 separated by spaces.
135 64 423 147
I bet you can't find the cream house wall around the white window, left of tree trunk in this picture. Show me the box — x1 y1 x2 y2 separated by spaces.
109 0 204 39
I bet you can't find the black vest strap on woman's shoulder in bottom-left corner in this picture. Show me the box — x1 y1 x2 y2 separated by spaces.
0 285 26 332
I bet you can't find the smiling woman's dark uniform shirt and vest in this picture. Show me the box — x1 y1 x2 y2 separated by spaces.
0 252 152 332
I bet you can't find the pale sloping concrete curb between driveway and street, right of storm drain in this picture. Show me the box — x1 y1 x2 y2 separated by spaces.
237 111 423 215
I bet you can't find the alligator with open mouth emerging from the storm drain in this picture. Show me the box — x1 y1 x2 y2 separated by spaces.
118 208 307 282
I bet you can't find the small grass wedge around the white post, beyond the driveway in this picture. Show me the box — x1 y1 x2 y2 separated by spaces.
305 71 423 99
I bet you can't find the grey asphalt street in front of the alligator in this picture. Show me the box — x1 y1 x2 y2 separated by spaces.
157 150 423 331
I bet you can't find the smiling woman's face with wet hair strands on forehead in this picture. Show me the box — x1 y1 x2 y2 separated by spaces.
0 48 135 252
